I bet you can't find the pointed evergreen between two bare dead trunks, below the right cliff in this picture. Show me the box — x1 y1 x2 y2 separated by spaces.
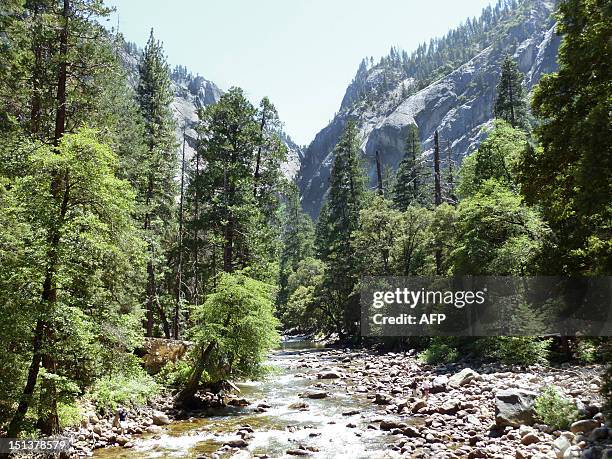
393 124 431 212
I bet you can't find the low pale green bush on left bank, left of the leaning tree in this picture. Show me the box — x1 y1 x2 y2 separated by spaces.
89 370 161 413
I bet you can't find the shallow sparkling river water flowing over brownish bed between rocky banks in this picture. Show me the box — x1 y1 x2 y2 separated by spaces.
94 341 402 459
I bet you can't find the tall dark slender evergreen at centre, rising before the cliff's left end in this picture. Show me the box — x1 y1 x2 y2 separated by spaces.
318 121 366 335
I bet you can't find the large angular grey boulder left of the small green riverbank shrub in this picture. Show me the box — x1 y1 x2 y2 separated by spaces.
495 389 538 427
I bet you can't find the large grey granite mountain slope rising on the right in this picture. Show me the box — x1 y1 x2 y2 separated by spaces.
299 0 559 216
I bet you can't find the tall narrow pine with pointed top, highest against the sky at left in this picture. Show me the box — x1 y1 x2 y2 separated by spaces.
137 30 178 338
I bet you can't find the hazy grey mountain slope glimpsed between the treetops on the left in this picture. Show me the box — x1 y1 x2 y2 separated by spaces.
121 43 303 178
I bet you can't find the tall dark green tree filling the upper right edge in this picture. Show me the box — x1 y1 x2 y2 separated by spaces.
521 0 612 274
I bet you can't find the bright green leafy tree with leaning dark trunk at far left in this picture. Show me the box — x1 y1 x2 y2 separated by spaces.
2 130 143 437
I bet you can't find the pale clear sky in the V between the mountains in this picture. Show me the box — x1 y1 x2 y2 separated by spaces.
106 0 493 144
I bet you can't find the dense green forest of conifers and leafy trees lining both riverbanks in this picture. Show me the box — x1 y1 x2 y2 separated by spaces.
0 0 612 457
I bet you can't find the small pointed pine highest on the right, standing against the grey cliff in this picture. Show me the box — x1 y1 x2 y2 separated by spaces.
494 56 528 129
